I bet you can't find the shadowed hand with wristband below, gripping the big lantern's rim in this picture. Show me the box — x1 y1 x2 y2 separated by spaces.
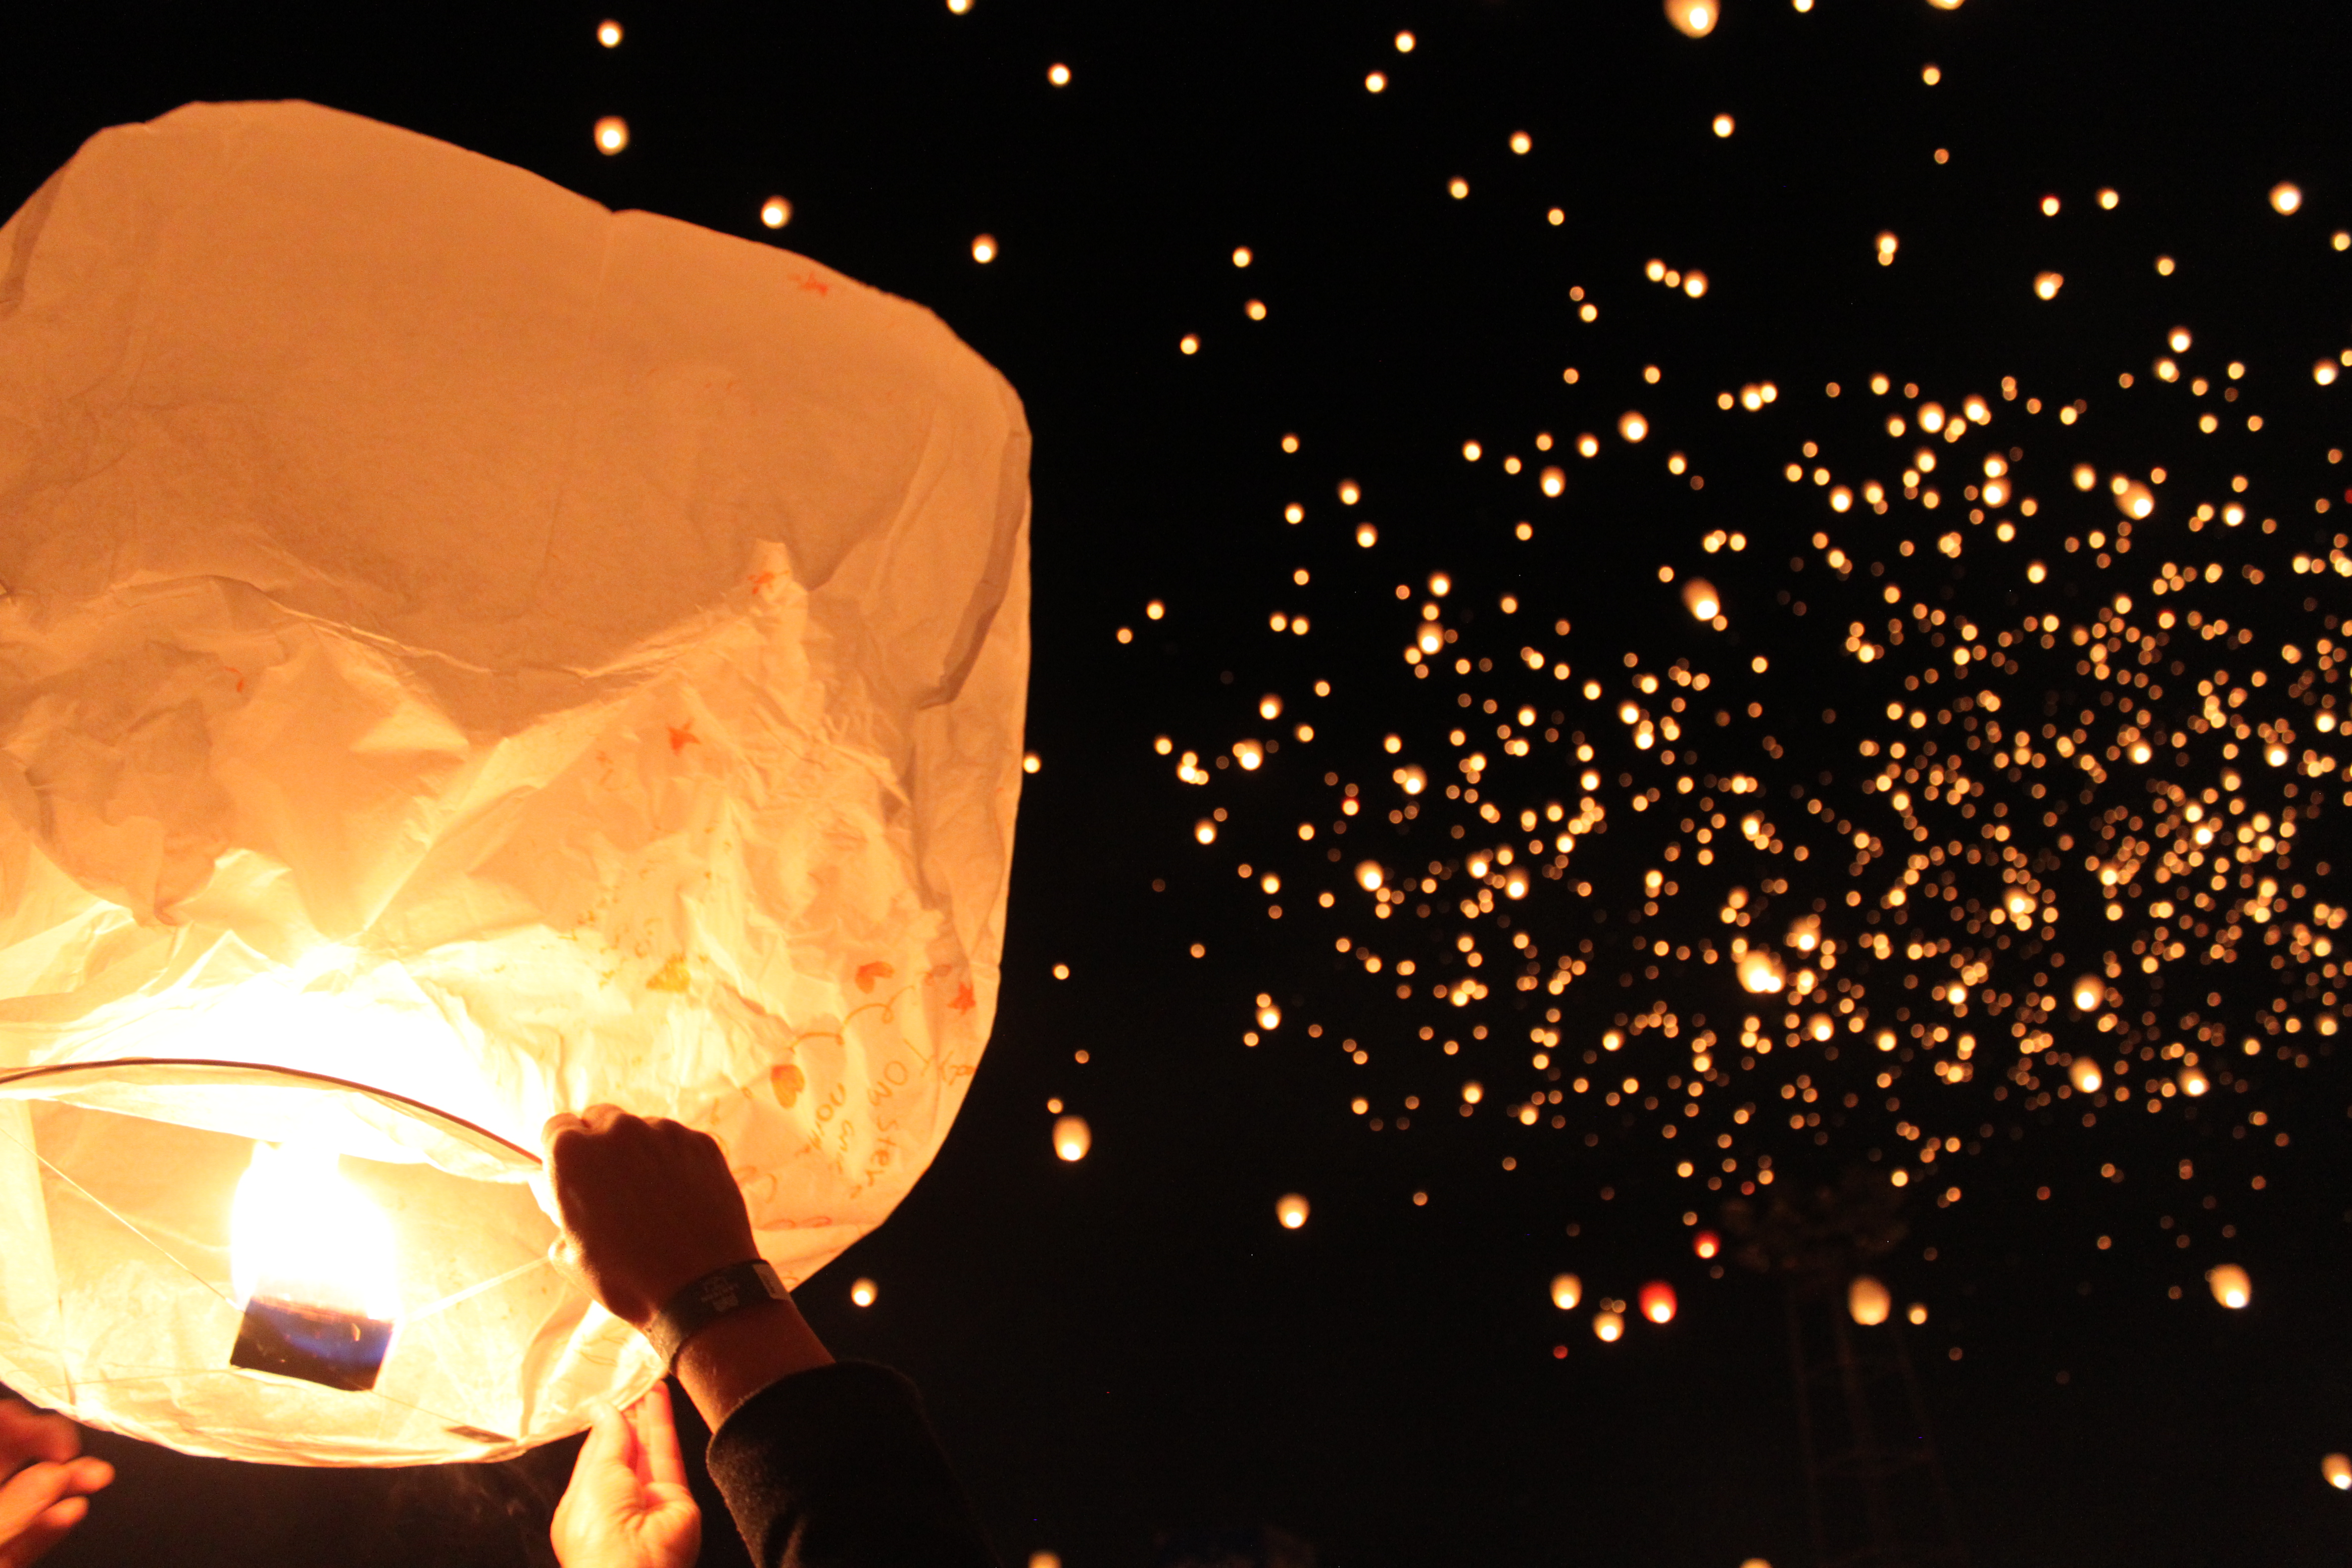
539 1105 760 1328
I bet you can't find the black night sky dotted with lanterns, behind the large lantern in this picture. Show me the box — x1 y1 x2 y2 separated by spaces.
0 0 2352 1568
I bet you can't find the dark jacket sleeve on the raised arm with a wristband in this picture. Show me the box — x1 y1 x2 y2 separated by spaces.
708 1361 997 1568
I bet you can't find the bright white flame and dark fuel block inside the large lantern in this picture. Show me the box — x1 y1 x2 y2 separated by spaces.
228 1142 400 1392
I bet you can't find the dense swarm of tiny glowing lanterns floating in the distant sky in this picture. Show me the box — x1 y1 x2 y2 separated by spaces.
1124 0 2352 1372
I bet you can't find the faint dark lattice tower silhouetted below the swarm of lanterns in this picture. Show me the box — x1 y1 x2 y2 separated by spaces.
1724 1169 1968 1568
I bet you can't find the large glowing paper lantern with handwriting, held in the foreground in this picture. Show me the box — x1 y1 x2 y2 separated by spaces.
0 103 1028 1465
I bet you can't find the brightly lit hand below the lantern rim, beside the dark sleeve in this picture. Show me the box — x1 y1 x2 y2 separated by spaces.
548 1382 703 1568
